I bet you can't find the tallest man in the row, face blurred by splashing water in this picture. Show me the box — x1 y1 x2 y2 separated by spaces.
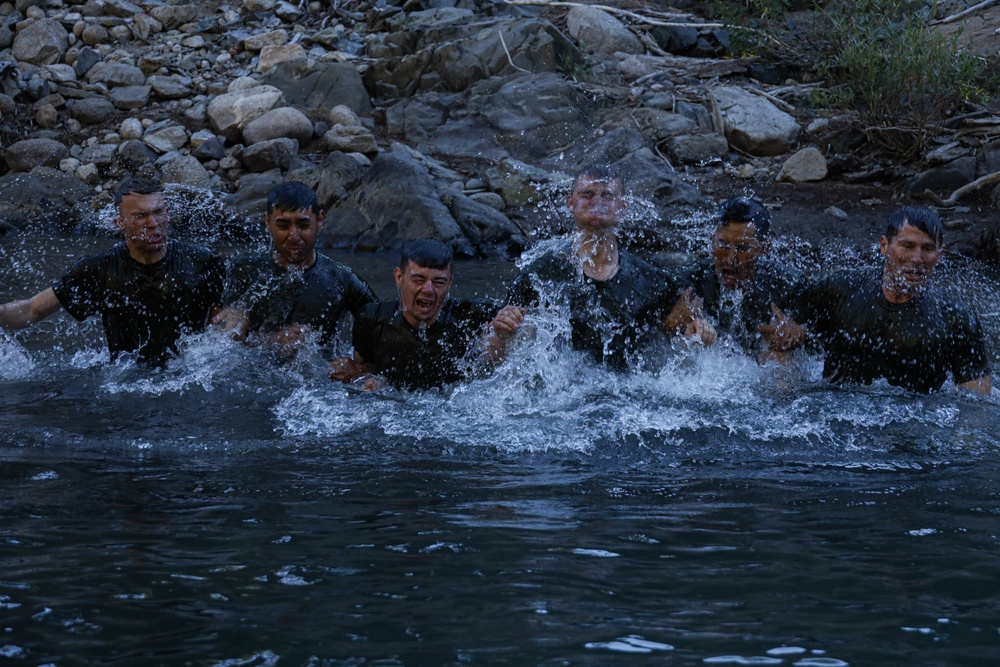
500 166 715 370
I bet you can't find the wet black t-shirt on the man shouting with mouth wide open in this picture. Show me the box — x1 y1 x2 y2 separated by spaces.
353 299 499 389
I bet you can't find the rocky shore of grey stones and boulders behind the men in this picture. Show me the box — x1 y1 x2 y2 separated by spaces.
0 0 1000 260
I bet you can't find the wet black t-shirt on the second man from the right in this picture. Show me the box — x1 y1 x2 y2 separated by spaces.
681 259 802 354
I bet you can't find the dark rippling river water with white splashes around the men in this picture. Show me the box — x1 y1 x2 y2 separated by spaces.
0 231 1000 667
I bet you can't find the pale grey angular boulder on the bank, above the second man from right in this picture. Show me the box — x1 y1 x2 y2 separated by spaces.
712 86 802 155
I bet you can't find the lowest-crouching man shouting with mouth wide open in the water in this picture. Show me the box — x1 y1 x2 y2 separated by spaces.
330 239 520 390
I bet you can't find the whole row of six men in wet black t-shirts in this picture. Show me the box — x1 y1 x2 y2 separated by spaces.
0 166 991 394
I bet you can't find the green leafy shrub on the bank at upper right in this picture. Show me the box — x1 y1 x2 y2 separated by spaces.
814 0 986 157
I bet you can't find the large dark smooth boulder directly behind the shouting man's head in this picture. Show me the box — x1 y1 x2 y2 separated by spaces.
320 151 474 255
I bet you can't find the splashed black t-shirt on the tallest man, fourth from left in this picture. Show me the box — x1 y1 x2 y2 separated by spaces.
507 241 679 370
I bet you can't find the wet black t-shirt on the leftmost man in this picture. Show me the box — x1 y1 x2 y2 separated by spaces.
52 241 226 365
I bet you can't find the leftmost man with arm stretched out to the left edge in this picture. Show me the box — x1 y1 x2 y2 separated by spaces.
0 177 225 365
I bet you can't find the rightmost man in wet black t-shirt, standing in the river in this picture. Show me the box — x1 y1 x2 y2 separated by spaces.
799 206 992 394
